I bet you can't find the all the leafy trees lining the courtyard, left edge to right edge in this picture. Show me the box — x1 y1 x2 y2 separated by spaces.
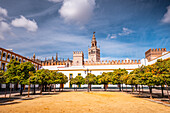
0 59 170 98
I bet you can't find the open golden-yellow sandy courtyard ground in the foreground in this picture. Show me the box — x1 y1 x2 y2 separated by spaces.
0 92 170 113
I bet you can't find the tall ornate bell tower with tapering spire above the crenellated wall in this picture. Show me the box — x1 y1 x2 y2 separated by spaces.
88 32 100 62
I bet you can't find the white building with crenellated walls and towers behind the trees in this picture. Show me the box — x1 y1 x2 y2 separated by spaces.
42 33 170 88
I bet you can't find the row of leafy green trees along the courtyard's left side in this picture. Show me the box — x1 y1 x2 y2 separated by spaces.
0 60 68 96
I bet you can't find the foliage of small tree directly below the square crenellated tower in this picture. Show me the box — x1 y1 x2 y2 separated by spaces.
70 75 85 85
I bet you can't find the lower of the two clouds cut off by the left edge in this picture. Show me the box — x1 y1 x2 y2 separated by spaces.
0 22 11 40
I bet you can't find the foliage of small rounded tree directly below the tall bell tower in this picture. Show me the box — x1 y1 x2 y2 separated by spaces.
85 73 97 84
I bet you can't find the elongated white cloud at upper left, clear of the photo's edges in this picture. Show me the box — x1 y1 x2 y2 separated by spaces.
11 15 38 32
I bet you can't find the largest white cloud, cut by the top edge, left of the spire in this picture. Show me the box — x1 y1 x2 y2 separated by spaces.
59 0 95 24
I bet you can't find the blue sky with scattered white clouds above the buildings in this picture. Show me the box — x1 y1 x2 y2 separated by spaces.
0 0 170 60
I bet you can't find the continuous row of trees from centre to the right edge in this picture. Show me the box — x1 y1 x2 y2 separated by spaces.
71 59 170 98
